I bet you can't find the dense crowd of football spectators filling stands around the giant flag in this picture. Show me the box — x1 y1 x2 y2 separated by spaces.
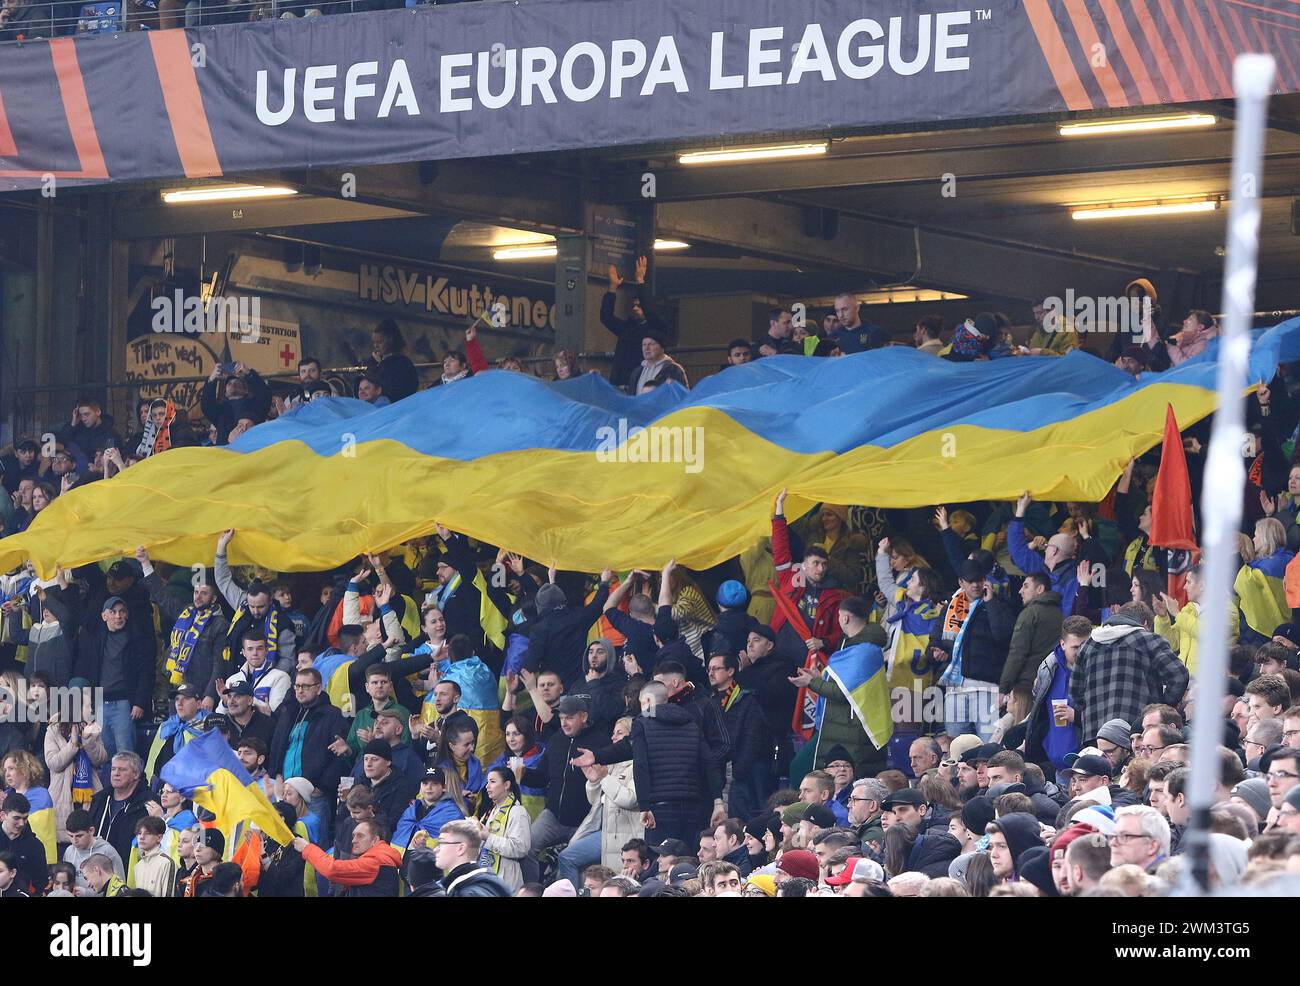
0 271 1300 896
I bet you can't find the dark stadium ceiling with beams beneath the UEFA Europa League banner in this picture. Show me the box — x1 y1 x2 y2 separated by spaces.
106 95 1300 304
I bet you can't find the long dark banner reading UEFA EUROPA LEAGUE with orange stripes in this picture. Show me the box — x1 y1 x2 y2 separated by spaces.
0 0 1300 189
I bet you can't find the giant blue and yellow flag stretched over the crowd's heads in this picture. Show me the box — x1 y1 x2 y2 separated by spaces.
0 319 1300 578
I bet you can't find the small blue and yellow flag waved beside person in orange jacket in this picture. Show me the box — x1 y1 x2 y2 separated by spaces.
161 730 294 851
